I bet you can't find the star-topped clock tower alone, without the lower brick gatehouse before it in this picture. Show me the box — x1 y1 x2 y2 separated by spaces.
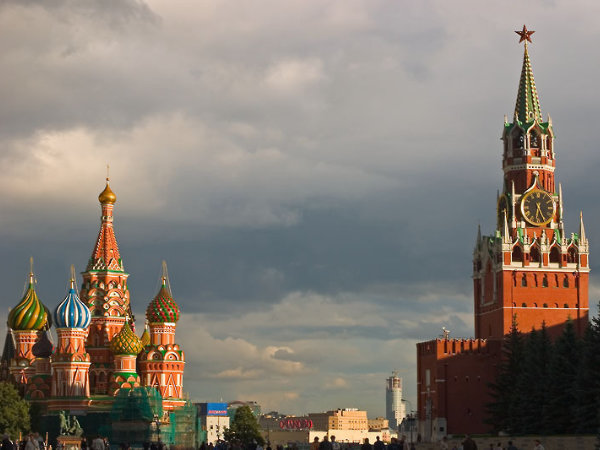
473 26 590 339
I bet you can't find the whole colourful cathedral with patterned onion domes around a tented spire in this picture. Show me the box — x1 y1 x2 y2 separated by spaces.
0 178 186 428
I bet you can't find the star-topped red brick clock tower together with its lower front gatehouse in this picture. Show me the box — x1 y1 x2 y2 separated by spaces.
417 26 590 439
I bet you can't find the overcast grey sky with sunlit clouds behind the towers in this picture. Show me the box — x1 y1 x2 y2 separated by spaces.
0 0 600 417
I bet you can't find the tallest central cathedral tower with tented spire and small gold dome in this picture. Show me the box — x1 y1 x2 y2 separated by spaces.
81 177 131 395
